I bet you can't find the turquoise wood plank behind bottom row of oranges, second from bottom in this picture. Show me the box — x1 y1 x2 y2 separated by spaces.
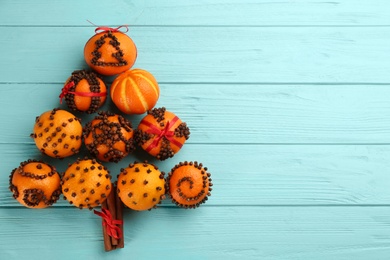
0 144 390 208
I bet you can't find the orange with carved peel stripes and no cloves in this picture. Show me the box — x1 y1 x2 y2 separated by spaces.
110 69 160 114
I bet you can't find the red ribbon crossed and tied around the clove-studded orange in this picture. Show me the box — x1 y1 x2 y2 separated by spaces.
140 116 183 152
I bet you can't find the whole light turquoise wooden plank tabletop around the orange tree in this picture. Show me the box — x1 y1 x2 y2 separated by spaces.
0 0 390 259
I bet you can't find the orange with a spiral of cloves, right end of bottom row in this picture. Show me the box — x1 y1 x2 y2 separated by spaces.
167 162 212 208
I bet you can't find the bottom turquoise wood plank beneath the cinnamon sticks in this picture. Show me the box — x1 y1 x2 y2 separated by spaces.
0 207 390 260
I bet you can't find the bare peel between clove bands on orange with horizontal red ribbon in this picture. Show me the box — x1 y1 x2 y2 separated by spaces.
65 75 107 112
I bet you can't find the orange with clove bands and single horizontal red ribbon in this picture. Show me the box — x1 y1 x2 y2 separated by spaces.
60 70 107 114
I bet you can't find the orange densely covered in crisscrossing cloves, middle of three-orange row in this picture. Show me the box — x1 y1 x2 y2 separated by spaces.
83 111 135 162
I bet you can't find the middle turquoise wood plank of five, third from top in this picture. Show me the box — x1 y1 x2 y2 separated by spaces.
0 84 390 144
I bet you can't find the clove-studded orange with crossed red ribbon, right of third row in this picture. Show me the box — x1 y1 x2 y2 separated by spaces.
135 107 190 160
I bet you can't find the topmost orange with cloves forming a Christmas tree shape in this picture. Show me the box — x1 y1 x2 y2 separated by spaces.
84 32 137 76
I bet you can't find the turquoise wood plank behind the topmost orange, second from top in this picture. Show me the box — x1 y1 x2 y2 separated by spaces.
0 27 390 84
